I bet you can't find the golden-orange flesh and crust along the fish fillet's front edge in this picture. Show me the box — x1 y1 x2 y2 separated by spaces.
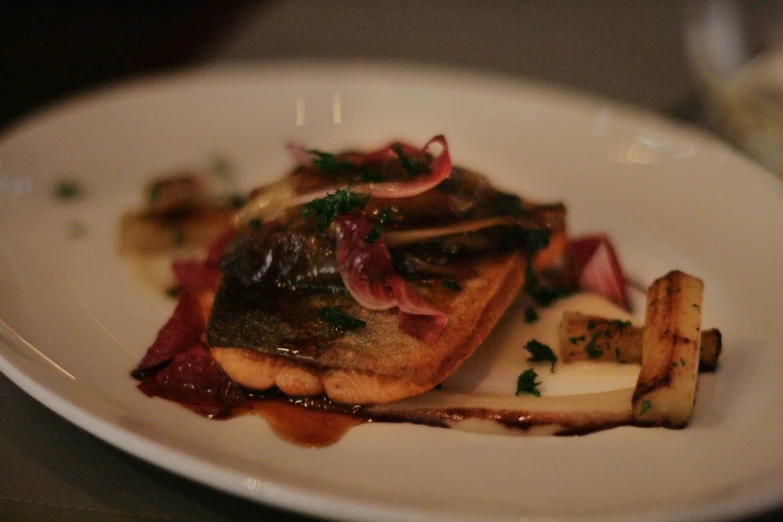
212 253 525 404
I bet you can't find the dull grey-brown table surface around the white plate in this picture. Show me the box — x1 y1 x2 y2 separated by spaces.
0 0 783 522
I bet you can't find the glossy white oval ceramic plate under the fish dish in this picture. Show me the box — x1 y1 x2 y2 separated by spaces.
0 64 783 521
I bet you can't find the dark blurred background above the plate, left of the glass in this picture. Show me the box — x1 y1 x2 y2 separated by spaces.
0 0 693 123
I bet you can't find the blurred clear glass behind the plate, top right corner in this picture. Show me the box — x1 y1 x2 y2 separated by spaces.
685 0 783 177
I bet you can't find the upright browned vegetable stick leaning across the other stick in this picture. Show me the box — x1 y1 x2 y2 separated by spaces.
633 271 704 428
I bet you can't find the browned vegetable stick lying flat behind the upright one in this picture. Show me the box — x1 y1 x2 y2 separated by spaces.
560 312 722 372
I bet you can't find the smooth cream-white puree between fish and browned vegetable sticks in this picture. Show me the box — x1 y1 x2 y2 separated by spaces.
443 293 639 396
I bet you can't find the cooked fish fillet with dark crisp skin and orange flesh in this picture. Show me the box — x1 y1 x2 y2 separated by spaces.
207 252 526 404
